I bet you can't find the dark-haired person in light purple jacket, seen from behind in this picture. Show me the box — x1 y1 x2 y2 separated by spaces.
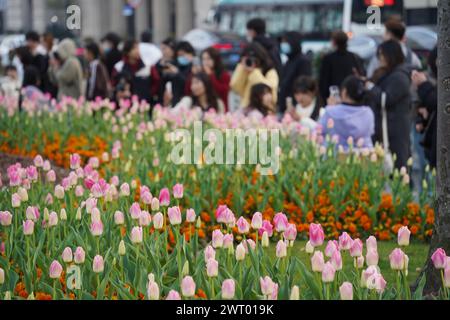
319 76 375 150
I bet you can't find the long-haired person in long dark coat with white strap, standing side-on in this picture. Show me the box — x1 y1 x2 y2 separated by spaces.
369 40 412 169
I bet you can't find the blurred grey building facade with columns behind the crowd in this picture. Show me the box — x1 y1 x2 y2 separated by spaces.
0 0 216 42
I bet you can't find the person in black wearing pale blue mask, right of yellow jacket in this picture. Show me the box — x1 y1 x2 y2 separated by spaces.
278 31 312 113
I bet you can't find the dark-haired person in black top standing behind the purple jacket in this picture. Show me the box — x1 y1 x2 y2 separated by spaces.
319 31 365 101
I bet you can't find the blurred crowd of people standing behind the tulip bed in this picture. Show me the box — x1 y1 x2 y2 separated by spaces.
0 18 437 175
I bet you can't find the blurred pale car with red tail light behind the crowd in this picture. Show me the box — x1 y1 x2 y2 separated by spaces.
183 29 245 70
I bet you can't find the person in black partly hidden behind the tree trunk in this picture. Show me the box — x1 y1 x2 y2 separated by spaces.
412 48 437 168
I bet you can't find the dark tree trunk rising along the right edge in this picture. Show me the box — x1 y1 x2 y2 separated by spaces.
422 0 450 295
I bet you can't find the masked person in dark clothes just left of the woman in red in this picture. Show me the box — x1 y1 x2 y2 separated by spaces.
165 41 195 105
